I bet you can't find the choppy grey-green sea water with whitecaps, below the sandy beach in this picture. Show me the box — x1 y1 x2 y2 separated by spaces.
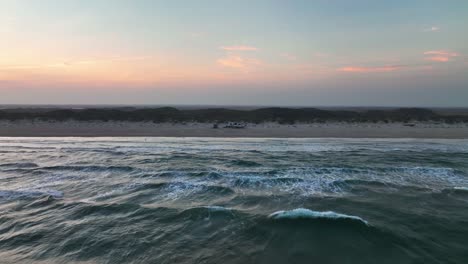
0 138 468 263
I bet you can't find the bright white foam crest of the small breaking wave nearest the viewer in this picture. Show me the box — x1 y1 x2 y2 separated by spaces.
268 208 368 225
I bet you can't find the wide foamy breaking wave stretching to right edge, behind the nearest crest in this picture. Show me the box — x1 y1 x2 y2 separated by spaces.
132 166 468 196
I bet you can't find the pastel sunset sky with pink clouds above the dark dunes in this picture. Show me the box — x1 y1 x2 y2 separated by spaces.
0 0 468 107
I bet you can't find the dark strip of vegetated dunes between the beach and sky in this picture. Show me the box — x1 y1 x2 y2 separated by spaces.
0 107 468 124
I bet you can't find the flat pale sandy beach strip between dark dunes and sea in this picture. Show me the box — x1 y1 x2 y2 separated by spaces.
0 120 468 139
